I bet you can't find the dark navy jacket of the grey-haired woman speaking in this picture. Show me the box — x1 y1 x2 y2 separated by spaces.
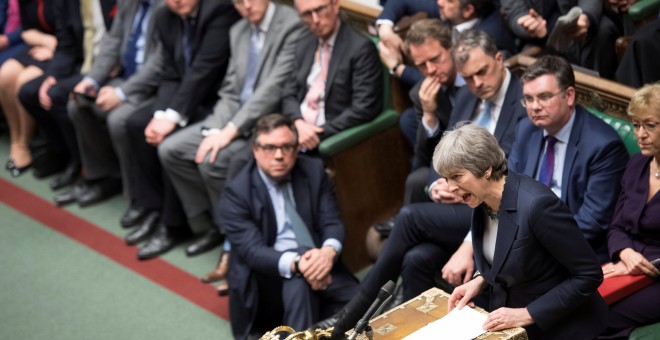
472 172 608 339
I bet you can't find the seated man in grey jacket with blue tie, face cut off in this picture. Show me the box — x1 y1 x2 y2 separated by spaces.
56 0 161 209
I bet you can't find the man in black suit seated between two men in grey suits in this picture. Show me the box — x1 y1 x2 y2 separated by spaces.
120 0 240 259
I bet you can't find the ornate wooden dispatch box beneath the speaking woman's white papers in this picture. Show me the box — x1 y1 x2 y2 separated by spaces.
346 288 527 340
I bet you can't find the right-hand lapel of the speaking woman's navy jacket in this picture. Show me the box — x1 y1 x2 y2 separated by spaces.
491 173 520 278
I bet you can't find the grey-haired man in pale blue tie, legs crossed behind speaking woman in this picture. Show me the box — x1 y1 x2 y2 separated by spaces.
328 30 525 335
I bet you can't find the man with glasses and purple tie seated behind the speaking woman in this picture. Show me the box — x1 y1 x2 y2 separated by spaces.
509 56 628 262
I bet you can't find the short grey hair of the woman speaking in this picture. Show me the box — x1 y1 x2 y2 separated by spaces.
433 122 508 180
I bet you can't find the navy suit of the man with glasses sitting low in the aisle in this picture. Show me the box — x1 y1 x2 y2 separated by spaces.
219 156 357 339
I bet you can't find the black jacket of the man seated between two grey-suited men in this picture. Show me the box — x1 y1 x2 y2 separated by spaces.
152 0 240 118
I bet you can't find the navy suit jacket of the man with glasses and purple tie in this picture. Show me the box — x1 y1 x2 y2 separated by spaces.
509 106 628 260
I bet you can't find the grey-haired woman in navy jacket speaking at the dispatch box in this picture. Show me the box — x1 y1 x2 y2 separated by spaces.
433 124 607 339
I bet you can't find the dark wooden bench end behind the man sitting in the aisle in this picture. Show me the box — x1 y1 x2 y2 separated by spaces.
326 125 412 272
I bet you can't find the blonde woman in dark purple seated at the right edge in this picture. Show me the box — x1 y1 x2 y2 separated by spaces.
601 83 660 339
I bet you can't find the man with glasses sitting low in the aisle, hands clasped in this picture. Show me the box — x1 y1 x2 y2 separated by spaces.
219 114 358 339
